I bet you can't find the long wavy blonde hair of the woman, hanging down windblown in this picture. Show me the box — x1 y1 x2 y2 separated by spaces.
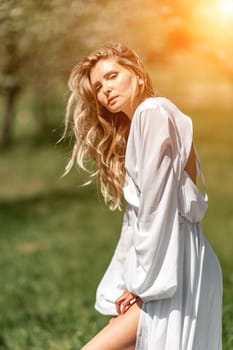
64 43 154 210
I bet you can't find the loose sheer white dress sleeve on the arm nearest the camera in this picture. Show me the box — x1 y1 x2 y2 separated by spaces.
124 106 180 302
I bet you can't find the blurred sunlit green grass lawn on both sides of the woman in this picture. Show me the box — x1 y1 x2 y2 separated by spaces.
0 111 233 350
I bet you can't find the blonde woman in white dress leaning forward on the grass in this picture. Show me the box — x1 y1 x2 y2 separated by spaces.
63 44 222 350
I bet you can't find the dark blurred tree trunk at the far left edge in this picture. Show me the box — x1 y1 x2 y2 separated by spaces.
1 87 19 147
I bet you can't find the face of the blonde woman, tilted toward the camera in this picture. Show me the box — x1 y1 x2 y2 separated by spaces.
90 58 141 118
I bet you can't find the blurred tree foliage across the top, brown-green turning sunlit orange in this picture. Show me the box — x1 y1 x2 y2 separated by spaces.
0 0 232 145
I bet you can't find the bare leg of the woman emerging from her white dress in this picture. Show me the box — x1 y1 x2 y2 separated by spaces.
81 303 141 350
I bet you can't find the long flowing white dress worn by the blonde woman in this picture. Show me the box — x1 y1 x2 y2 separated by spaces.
95 97 222 350
